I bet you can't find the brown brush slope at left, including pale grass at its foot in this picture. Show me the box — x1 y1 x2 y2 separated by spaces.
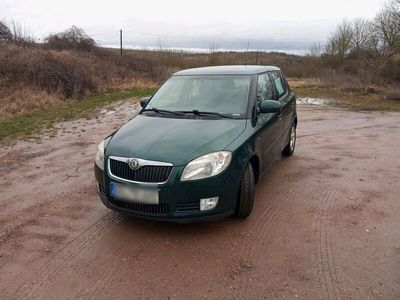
0 43 162 120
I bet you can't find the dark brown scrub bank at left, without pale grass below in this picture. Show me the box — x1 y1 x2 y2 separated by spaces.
0 43 163 99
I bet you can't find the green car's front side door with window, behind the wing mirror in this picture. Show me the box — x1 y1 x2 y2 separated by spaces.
257 73 282 172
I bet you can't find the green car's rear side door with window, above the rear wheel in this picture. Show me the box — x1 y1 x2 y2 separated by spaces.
270 71 296 151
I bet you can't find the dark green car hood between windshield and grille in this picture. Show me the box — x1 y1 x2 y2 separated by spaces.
106 115 246 166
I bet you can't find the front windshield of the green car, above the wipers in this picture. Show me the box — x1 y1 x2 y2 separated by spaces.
146 75 251 116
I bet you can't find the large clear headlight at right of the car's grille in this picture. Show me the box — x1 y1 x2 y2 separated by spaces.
181 151 232 181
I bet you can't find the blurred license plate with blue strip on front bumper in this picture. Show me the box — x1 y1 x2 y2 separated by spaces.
110 182 159 204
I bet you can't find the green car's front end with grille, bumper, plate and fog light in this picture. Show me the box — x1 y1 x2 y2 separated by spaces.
95 143 244 222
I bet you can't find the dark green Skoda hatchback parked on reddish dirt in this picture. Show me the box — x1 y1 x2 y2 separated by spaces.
95 66 297 222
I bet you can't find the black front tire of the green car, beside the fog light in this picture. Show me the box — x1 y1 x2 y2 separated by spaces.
234 163 255 219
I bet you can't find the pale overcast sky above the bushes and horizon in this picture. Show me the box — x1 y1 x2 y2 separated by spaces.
0 0 384 49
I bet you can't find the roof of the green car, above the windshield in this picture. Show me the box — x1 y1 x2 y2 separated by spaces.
174 65 280 76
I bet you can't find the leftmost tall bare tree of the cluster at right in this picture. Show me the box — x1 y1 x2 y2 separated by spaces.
326 20 353 63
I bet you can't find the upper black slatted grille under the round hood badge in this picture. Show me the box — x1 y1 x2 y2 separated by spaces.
110 159 172 183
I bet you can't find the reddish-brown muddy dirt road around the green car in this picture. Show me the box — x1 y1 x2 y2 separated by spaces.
0 102 400 299
